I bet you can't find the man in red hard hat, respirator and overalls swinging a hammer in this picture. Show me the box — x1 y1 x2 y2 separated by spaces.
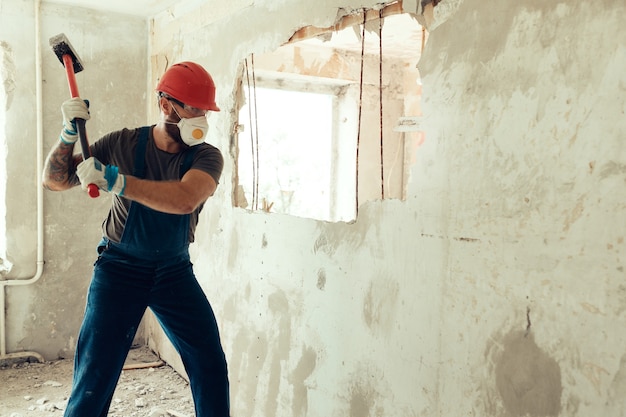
43 62 229 417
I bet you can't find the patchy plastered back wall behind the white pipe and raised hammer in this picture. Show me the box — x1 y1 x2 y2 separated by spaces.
0 0 146 359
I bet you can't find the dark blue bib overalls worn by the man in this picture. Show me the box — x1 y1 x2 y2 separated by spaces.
65 127 230 417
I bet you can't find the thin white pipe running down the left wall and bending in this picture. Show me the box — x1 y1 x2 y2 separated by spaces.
0 0 45 362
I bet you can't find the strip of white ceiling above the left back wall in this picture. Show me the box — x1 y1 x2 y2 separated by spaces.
43 0 183 18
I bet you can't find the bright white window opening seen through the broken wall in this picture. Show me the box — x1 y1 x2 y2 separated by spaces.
238 87 333 220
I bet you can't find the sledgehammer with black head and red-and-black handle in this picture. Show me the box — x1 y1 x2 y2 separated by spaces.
50 33 100 198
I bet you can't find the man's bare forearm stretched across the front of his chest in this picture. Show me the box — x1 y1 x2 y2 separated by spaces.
124 169 217 214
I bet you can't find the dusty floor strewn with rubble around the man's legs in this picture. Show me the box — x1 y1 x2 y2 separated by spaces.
0 347 194 417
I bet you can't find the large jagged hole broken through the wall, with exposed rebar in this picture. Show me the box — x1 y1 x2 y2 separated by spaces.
231 2 426 222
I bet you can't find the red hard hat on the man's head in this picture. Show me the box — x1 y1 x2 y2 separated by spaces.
156 61 220 111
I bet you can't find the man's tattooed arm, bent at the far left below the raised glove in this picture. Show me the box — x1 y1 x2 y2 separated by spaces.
42 140 83 191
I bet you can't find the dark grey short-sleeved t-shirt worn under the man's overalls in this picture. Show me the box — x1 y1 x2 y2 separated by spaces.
90 126 224 243
